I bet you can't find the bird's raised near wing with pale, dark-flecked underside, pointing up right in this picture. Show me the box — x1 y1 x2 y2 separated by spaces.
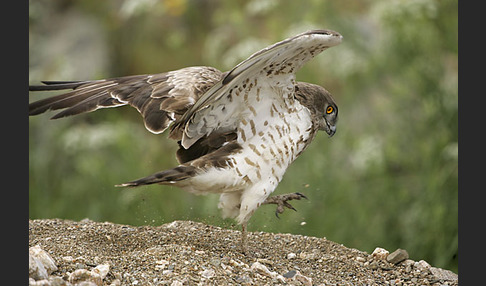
170 30 342 149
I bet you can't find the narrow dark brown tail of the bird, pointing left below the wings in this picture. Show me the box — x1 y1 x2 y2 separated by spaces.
115 165 196 187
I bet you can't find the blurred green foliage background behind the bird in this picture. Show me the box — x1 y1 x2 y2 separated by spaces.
29 0 458 272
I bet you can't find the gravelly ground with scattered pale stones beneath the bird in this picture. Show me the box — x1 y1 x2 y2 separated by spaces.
29 219 458 286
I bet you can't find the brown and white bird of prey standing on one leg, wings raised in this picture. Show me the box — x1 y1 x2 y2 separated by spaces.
29 30 342 251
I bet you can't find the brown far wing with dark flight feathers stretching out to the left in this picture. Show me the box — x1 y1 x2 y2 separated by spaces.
29 67 223 134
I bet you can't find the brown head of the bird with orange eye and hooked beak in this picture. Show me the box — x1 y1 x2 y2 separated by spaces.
295 82 338 137
